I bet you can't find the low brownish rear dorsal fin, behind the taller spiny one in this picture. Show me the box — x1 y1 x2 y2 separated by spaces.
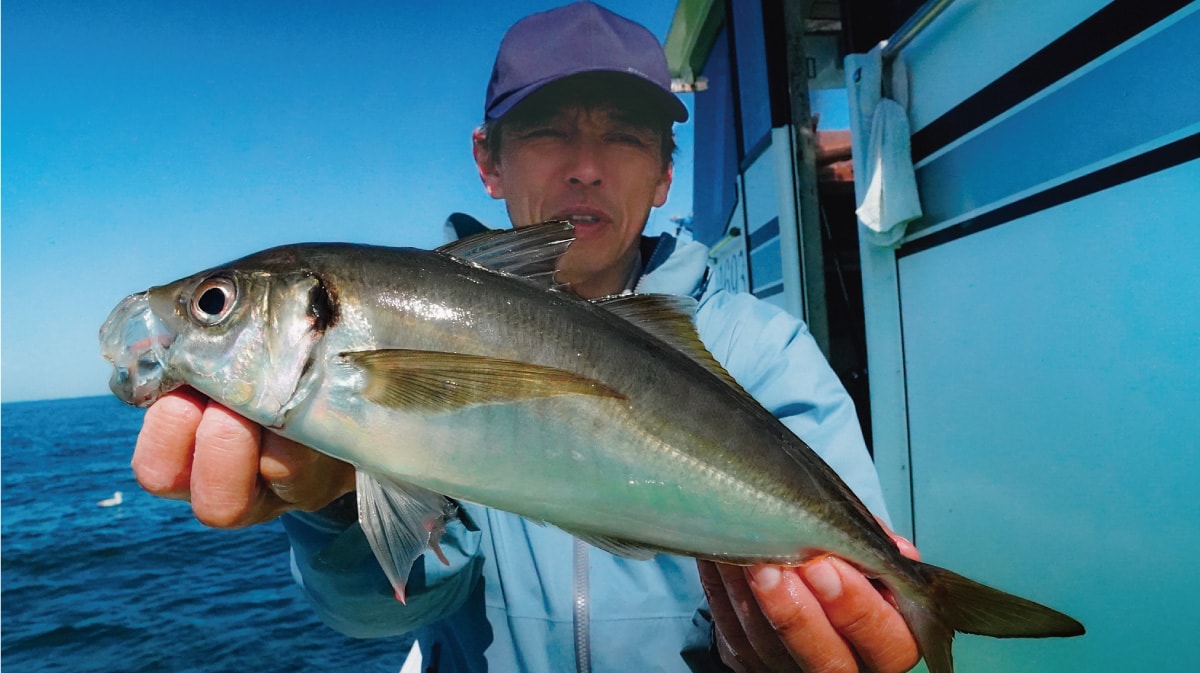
593 294 749 395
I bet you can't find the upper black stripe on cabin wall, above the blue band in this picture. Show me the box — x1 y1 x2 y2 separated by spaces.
912 0 1189 163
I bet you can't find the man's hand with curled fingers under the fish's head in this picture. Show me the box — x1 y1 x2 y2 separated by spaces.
132 389 354 528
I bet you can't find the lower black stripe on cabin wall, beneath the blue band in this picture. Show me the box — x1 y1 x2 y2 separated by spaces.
896 133 1200 259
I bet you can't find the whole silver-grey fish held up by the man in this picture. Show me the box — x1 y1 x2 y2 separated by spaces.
100 222 1085 673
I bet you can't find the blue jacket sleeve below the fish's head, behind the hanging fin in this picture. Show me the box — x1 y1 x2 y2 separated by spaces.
281 494 484 638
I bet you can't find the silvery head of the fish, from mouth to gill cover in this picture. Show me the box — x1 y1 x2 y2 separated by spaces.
100 256 336 427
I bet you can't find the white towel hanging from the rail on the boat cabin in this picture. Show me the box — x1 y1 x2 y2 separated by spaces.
856 44 922 246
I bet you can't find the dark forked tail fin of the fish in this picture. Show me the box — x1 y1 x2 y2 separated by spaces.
893 561 1084 673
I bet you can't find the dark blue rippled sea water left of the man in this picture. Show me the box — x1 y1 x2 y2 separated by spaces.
0 397 408 673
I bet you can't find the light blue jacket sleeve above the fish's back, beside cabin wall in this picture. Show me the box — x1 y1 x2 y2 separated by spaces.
696 290 890 525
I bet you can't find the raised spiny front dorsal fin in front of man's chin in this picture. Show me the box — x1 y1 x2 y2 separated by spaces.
438 220 575 289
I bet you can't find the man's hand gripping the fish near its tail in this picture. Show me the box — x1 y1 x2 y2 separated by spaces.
700 531 920 673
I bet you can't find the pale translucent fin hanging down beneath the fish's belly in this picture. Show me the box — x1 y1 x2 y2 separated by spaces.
355 470 458 602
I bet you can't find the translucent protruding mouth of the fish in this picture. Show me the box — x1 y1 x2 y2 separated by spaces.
100 293 179 407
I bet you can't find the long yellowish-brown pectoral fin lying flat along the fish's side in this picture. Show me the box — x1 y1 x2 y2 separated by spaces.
342 349 625 411
